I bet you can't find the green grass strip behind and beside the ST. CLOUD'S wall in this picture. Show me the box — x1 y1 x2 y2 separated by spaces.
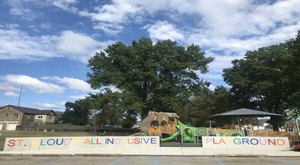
0 131 95 151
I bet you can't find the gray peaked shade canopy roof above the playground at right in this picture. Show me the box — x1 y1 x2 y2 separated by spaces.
210 108 283 117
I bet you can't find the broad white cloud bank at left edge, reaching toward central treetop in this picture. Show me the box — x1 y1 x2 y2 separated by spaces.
0 25 113 63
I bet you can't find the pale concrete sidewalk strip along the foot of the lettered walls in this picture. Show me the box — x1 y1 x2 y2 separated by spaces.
0 147 300 157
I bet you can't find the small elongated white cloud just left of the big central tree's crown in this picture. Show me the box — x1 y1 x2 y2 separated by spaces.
43 76 95 92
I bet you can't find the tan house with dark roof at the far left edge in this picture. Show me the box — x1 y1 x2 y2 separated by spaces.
0 105 56 130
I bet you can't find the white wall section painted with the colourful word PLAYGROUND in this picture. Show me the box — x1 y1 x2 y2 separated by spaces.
202 136 290 150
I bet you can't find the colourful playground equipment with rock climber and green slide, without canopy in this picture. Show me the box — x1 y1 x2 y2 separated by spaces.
140 111 299 143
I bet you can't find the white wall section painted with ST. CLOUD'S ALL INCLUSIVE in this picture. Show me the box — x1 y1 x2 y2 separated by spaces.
4 136 160 151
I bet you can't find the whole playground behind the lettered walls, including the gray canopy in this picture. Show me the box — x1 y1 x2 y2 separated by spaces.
141 108 299 144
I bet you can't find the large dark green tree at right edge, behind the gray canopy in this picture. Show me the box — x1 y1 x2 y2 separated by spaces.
223 31 300 129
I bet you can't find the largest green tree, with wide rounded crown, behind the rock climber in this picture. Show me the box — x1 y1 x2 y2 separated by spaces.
88 38 213 118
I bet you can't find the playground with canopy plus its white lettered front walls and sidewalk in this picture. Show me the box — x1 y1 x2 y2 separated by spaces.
0 109 300 156
